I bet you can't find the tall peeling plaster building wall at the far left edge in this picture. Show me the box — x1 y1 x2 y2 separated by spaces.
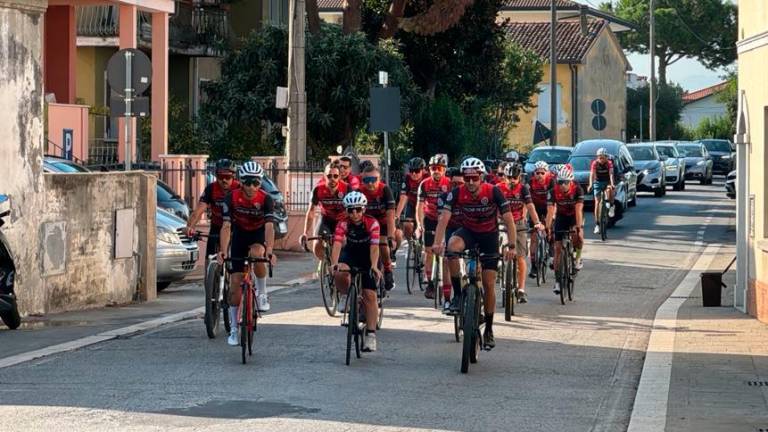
0 0 46 318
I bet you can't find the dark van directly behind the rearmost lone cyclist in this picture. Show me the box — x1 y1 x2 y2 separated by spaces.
568 139 637 223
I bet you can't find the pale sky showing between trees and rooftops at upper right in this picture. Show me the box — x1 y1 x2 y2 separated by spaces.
575 0 726 91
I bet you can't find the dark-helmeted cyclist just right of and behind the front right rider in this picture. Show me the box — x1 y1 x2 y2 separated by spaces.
498 163 543 303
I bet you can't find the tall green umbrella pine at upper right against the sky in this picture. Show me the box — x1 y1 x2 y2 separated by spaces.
602 0 737 84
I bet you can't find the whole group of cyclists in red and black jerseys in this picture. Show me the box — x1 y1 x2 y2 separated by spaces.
187 149 613 351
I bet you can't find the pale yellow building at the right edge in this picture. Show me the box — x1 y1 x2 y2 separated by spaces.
734 0 768 322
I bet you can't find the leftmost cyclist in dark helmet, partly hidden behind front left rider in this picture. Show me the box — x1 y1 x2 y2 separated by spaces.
187 159 240 257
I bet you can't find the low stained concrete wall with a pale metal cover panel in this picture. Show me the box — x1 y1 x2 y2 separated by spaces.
42 172 157 313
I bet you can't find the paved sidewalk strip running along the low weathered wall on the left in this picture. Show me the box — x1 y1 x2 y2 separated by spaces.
0 252 315 364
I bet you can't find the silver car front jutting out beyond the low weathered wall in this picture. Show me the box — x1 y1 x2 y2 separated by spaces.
155 208 200 291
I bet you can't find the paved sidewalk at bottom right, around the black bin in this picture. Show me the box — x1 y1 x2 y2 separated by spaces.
665 246 768 432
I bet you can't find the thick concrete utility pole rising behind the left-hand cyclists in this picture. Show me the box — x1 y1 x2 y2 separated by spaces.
286 0 307 167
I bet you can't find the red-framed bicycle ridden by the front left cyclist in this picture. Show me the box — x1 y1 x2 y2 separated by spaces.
224 257 272 364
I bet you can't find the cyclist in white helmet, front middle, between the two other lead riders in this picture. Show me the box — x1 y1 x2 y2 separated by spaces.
331 191 381 351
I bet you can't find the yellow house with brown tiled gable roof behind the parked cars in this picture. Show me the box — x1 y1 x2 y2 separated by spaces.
505 19 631 148
